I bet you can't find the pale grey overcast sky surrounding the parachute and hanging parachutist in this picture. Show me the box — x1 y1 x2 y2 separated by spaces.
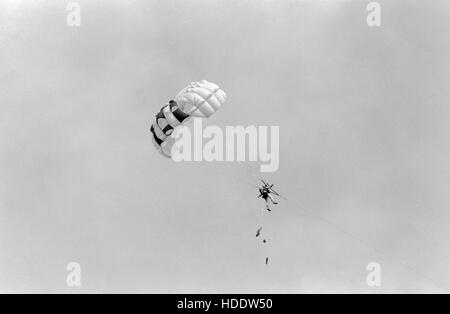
0 0 450 293
